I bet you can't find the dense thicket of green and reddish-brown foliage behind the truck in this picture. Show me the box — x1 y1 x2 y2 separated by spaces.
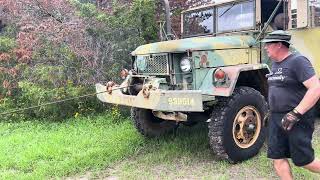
0 0 215 117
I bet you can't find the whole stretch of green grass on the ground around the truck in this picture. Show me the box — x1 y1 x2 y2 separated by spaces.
0 115 320 179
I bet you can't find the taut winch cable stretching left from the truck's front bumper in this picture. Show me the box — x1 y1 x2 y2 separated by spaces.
0 85 132 115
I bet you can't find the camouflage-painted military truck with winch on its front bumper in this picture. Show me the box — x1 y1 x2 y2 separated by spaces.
96 0 320 162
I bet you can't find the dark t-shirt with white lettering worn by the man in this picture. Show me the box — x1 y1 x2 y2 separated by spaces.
268 54 315 113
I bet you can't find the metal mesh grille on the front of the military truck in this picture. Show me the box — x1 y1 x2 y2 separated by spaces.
139 54 169 74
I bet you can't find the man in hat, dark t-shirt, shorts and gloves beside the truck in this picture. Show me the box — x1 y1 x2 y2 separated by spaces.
262 30 320 179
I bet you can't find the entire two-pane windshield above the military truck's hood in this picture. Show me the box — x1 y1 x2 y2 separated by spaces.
183 0 255 37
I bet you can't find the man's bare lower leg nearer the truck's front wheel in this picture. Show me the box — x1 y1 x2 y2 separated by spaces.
273 159 293 180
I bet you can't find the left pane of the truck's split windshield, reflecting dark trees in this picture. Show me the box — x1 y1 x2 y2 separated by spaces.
183 9 214 36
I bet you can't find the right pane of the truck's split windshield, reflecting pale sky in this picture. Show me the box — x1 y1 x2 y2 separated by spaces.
217 1 255 32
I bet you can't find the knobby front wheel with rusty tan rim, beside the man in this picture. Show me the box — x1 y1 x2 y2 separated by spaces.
209 87 268 163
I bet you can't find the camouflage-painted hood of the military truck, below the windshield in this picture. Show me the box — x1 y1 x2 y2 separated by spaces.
131 35 255 56
